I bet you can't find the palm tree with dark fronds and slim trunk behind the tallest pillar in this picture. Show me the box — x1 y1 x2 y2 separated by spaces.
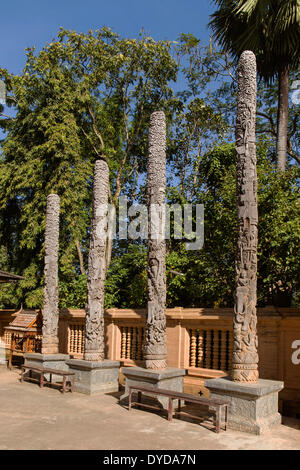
209 0 300 171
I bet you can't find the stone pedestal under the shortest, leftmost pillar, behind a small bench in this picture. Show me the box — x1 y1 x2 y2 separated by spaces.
24 353 70 382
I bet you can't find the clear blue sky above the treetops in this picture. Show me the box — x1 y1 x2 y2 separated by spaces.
0 0 216 74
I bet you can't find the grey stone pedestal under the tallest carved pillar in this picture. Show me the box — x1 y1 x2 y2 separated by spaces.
205 378 284 434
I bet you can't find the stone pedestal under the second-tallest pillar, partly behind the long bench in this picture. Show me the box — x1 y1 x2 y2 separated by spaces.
120 367 186 409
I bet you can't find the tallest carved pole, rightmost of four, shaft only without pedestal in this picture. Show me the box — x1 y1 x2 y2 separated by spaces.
232 51 258 382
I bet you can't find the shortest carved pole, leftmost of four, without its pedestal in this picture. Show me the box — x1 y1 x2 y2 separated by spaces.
42 194 60 354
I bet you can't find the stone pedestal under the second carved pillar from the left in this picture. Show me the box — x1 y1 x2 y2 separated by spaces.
67 359 120 395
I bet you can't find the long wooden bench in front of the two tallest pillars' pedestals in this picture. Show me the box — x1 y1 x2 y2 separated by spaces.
128 385 229 433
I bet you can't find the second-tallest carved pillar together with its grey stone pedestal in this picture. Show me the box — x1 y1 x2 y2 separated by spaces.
120 111 185 409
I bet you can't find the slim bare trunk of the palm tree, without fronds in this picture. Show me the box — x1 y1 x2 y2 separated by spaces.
277 64 289 171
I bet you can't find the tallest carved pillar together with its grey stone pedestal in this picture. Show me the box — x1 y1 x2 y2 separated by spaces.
205 51 284 434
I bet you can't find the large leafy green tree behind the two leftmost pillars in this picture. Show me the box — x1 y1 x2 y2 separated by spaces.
0 28 177 306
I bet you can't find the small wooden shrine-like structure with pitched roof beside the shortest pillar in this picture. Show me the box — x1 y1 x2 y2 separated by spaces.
5 308 43 369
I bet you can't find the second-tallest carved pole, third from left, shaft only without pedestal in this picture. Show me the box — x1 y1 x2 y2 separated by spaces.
144 111 167 369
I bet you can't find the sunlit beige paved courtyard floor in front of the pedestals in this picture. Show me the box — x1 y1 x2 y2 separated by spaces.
0 366 300 450
